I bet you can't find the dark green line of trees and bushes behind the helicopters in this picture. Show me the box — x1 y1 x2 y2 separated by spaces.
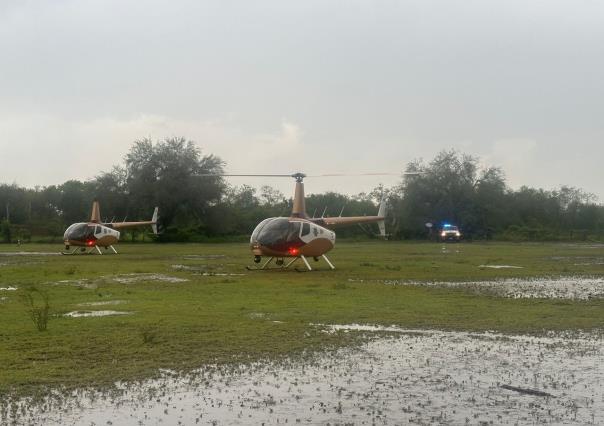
0 138 604 242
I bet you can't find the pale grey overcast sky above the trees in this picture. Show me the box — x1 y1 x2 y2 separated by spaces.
0 0 604 201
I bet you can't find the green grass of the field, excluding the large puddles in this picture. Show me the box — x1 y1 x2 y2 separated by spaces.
0 242 604 395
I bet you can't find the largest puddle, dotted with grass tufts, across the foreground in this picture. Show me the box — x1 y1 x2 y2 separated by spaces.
0 325 604 425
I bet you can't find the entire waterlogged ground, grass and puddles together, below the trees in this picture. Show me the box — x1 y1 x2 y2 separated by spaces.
0 242 604 425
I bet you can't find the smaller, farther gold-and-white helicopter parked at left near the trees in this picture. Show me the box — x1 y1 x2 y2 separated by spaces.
61 200 158 255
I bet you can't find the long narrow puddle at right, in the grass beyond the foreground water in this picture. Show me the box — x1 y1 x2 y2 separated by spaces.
348 277 604 300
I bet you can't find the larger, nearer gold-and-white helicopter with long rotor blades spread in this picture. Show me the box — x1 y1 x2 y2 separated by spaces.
201 173 398 271
